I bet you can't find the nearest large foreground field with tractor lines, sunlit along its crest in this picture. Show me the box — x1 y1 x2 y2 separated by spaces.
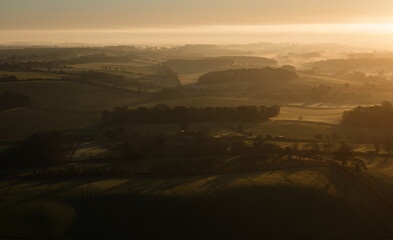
0 168 392 239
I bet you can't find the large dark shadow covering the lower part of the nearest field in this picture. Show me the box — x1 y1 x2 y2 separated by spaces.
31 186 393 239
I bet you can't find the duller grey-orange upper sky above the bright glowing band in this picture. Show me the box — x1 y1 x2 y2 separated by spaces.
0 0 393 29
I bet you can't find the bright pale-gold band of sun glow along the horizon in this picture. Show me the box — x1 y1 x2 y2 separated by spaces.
0 23 393 48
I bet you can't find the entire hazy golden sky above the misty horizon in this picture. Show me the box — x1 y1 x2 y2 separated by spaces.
0 0 393 44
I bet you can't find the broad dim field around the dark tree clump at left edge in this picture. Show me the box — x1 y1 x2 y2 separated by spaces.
0 81 150 141
